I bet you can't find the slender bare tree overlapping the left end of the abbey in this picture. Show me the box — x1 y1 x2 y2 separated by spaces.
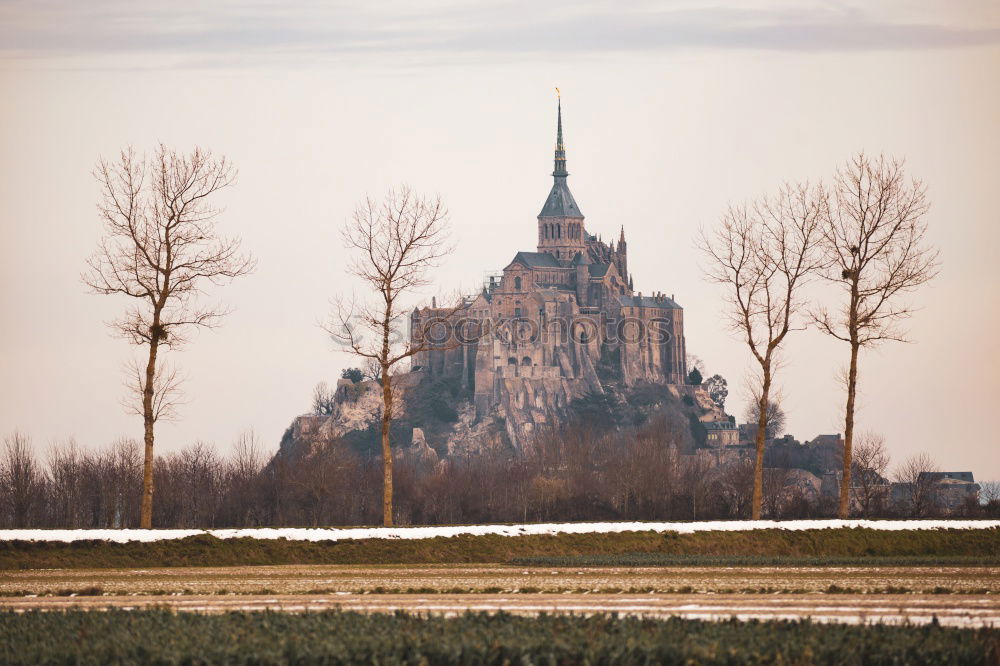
327 186 451 526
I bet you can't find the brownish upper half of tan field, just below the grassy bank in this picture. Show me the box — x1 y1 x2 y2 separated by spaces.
0 565 1000 592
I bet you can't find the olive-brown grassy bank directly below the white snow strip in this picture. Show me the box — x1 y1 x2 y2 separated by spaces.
0 528 1000 570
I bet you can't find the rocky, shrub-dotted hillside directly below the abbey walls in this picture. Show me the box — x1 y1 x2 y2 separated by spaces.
281 364 728 465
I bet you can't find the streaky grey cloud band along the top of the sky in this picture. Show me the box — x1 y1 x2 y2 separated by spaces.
0 0 1000 62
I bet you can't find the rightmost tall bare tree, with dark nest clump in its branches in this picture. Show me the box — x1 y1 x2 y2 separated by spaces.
814 153 938 518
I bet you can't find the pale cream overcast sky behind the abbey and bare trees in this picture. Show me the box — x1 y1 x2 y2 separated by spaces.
0 0 1000 478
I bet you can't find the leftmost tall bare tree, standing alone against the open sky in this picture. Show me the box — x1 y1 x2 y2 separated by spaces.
82 144 253 528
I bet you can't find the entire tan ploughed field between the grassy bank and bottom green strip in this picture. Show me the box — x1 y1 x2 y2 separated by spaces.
0 565 1000 627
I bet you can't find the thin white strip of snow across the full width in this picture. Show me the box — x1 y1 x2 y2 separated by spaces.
0 520 1000 543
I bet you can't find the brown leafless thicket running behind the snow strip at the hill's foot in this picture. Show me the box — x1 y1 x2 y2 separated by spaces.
0 426 1000 528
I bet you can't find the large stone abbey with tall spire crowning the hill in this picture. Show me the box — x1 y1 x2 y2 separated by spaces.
411 97 687 439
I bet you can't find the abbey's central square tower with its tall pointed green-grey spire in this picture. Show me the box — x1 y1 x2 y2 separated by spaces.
538 100 587 263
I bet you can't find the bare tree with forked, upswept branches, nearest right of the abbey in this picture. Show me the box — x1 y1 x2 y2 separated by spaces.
701 184 826 520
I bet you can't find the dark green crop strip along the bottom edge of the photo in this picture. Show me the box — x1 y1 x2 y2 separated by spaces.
0 610 1000 665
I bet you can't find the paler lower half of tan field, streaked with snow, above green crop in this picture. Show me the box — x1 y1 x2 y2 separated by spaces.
0 593 1000 627
